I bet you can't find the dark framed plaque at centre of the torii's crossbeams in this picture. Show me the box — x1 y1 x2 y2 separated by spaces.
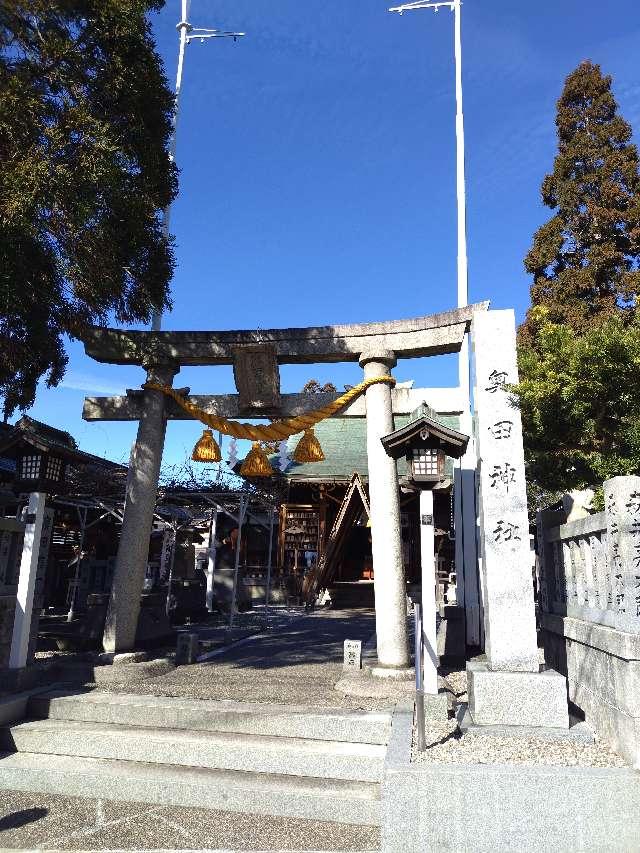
233 344 280 415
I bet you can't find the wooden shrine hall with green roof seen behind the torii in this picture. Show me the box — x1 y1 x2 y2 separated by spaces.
273 402 466 607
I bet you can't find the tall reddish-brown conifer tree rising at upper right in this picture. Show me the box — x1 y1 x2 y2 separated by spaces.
520 62 640 346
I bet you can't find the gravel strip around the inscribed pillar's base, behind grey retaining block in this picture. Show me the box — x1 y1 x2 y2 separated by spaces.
412 670 627 767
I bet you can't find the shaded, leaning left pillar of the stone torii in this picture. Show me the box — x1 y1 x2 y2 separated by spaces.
102 364 180 654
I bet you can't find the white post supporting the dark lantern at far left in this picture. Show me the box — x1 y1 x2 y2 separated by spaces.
9 492 47 669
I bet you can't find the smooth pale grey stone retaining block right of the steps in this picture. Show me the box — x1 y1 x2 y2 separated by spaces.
382 704 640 853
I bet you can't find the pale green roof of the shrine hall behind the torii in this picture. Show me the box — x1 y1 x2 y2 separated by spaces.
271 415 460 483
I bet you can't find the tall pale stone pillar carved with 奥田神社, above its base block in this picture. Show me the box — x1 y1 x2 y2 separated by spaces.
473 311 539 672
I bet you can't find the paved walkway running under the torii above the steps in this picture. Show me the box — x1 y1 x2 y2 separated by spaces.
94 610 392 710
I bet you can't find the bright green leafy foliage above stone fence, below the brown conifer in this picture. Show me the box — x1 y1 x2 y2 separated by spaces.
513 308 640 491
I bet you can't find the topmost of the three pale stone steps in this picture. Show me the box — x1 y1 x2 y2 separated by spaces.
28 690 391 744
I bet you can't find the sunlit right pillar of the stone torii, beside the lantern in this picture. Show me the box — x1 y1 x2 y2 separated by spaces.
360 350 409 676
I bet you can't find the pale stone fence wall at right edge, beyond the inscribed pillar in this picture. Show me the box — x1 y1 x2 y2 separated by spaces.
537 477 640 768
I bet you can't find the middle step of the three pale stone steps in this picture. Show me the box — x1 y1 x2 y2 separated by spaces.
0 719 386 782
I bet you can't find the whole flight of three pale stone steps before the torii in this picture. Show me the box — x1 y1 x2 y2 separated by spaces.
0 690 391 825
